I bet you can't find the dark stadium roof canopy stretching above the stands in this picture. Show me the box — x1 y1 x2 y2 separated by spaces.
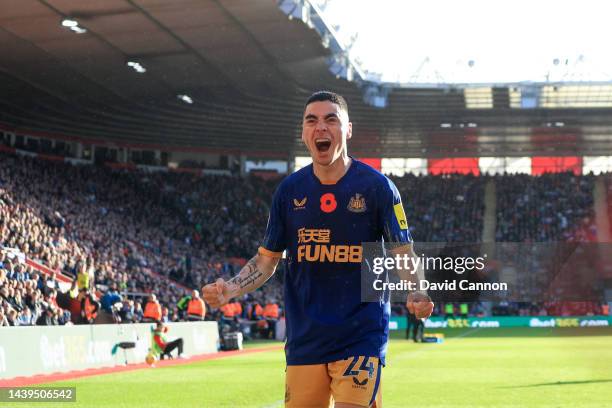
0 0 612 157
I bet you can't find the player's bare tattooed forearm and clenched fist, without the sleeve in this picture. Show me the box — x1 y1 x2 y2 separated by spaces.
202 254 280 307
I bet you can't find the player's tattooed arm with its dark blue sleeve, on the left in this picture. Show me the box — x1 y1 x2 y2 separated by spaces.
202 185 286 307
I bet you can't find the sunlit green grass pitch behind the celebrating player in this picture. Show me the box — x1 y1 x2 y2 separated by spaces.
5 328 612 408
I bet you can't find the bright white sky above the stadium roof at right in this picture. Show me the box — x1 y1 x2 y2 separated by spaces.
311 0 612 84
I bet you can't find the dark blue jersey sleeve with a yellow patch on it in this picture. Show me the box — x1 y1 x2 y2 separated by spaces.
379 179 412 244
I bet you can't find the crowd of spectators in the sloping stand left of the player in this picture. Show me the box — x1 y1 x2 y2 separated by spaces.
0 153 280 326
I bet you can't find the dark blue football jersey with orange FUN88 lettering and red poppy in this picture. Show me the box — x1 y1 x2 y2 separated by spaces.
259 159 412 365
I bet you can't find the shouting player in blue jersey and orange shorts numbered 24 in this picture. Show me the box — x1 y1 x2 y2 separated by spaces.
202 91 433 408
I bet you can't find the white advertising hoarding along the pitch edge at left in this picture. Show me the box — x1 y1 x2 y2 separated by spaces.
0 322 219 379
